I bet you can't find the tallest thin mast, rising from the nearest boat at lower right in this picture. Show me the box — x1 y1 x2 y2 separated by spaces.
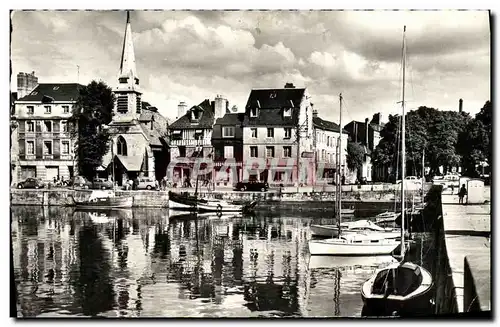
401 25 406 260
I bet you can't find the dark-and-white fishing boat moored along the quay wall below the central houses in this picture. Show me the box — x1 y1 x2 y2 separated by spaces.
168 192 257 212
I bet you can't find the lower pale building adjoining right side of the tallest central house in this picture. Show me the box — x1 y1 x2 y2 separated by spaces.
313 110 349 182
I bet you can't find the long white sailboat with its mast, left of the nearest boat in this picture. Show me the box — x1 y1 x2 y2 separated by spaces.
308 94 399 256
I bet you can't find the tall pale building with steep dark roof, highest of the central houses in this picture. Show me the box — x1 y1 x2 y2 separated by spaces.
243 83 314 185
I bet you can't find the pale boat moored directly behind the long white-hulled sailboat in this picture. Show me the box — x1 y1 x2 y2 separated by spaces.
310 219 400 238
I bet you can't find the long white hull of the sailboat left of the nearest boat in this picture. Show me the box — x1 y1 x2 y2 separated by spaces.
309 239 400 256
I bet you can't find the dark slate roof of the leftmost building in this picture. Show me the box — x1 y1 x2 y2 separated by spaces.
18 83 84 101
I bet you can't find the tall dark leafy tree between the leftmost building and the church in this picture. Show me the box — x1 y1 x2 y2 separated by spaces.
70 81 115 179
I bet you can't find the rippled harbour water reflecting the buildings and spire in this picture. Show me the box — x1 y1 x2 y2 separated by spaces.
12 207 434 317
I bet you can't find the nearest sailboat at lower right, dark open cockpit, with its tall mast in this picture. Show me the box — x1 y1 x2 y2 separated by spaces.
361 26 433 313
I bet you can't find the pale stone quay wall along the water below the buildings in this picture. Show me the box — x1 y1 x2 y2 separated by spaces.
10 185 420 210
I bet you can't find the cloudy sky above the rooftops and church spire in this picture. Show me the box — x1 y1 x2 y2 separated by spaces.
11 11 490 123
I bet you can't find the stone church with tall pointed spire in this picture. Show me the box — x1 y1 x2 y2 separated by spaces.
99 11 169 185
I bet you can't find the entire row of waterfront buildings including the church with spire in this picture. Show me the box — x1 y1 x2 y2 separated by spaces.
11 15 384 185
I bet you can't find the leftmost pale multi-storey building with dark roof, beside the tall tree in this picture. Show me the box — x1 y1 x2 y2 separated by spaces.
11 78 82 183
